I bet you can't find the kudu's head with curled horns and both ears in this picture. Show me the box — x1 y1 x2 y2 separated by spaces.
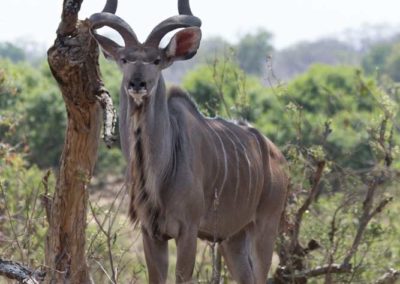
89 0 201 106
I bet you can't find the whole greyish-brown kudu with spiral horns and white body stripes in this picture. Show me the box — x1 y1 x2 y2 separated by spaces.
90 0 288 283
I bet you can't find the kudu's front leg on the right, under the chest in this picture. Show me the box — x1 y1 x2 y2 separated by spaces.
175 228 197 283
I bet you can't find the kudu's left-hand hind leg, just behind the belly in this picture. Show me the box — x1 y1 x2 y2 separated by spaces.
220 230 255 284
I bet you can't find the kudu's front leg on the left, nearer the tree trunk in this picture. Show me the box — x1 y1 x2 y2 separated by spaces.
142 228 168 284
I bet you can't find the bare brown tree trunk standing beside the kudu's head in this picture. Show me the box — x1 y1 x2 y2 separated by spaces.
45 0 111 284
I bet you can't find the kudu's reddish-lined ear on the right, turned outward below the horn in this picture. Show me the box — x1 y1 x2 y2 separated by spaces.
165 27 201 61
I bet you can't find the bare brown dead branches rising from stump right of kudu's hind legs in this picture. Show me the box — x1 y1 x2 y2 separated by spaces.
274 116 400 284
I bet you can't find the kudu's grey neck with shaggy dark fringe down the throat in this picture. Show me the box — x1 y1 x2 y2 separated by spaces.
128 76 180 234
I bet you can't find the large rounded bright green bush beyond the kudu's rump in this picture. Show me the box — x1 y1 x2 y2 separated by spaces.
258 65 395 169
